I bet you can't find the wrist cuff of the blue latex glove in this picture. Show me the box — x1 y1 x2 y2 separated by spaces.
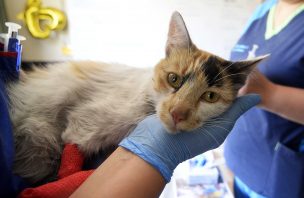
119 138 173 183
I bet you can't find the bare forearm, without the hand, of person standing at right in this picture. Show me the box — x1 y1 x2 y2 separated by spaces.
260 84 304 124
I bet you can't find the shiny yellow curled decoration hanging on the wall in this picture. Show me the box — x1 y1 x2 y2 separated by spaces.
18 0 67 39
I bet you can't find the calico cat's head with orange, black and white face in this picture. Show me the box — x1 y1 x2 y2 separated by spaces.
153 12 263 133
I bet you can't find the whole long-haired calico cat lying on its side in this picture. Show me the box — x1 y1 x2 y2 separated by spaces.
7 12 262 183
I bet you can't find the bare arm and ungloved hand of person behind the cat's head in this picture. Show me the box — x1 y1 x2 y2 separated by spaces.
240 71 304 124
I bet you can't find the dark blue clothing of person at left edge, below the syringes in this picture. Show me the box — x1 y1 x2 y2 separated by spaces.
0 54 26 198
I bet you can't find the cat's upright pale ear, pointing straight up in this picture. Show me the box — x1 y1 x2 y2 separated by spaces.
166 11 192 57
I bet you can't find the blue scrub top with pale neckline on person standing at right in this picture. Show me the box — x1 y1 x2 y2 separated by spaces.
224 1 304 198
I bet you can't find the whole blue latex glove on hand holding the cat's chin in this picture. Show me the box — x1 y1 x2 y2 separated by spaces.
119 94 260 182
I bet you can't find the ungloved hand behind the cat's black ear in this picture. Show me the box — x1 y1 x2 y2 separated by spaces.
239 70 276 107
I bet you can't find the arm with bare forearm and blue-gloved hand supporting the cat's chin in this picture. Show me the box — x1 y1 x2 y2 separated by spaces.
71 95 260 198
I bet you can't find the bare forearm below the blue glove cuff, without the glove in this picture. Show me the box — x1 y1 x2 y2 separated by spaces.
71 147 166 198
